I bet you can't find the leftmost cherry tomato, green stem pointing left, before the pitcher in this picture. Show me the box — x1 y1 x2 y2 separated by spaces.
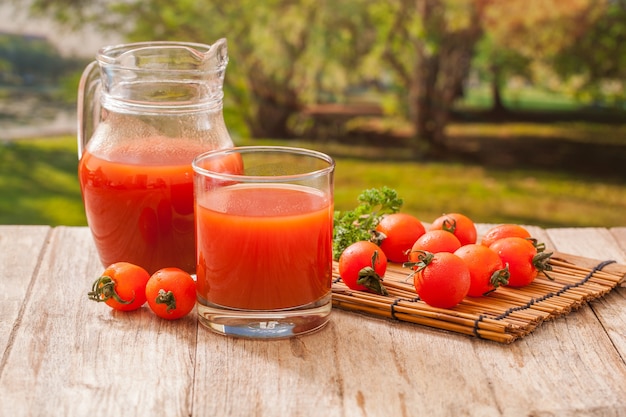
88 262 150 311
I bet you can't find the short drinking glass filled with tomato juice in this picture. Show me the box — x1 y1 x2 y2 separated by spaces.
192 146 335 339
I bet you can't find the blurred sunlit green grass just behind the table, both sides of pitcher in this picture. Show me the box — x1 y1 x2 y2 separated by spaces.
0 137 626 227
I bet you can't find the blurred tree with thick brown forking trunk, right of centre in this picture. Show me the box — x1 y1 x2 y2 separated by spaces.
372 0 489 153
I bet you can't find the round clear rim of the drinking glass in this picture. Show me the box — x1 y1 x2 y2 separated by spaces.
191 145 335 183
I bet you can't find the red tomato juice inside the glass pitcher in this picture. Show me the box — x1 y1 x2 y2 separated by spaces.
78 148 202 273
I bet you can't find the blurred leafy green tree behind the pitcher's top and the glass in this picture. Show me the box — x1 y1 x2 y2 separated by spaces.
26 0 367 138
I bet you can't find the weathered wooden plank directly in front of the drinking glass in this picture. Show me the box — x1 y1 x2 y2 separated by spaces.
194 310 498 417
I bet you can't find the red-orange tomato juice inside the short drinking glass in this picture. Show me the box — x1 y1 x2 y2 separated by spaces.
196 185 333 310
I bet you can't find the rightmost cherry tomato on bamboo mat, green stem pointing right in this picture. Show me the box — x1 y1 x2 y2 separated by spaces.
489 236 552 287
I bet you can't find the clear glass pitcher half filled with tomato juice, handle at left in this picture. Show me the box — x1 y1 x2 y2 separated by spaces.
78 39 233 274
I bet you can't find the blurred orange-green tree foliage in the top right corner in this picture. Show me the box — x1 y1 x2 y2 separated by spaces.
474 0 608 112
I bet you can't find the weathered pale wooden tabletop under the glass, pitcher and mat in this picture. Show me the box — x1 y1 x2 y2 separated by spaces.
0 225 626 417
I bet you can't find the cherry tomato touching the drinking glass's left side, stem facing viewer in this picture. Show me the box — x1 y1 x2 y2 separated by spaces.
146 268 196 320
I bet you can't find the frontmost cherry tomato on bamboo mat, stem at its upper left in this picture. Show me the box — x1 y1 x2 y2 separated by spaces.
413 252 471 308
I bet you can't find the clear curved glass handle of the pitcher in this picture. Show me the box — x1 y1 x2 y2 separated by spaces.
77 61 101 159
